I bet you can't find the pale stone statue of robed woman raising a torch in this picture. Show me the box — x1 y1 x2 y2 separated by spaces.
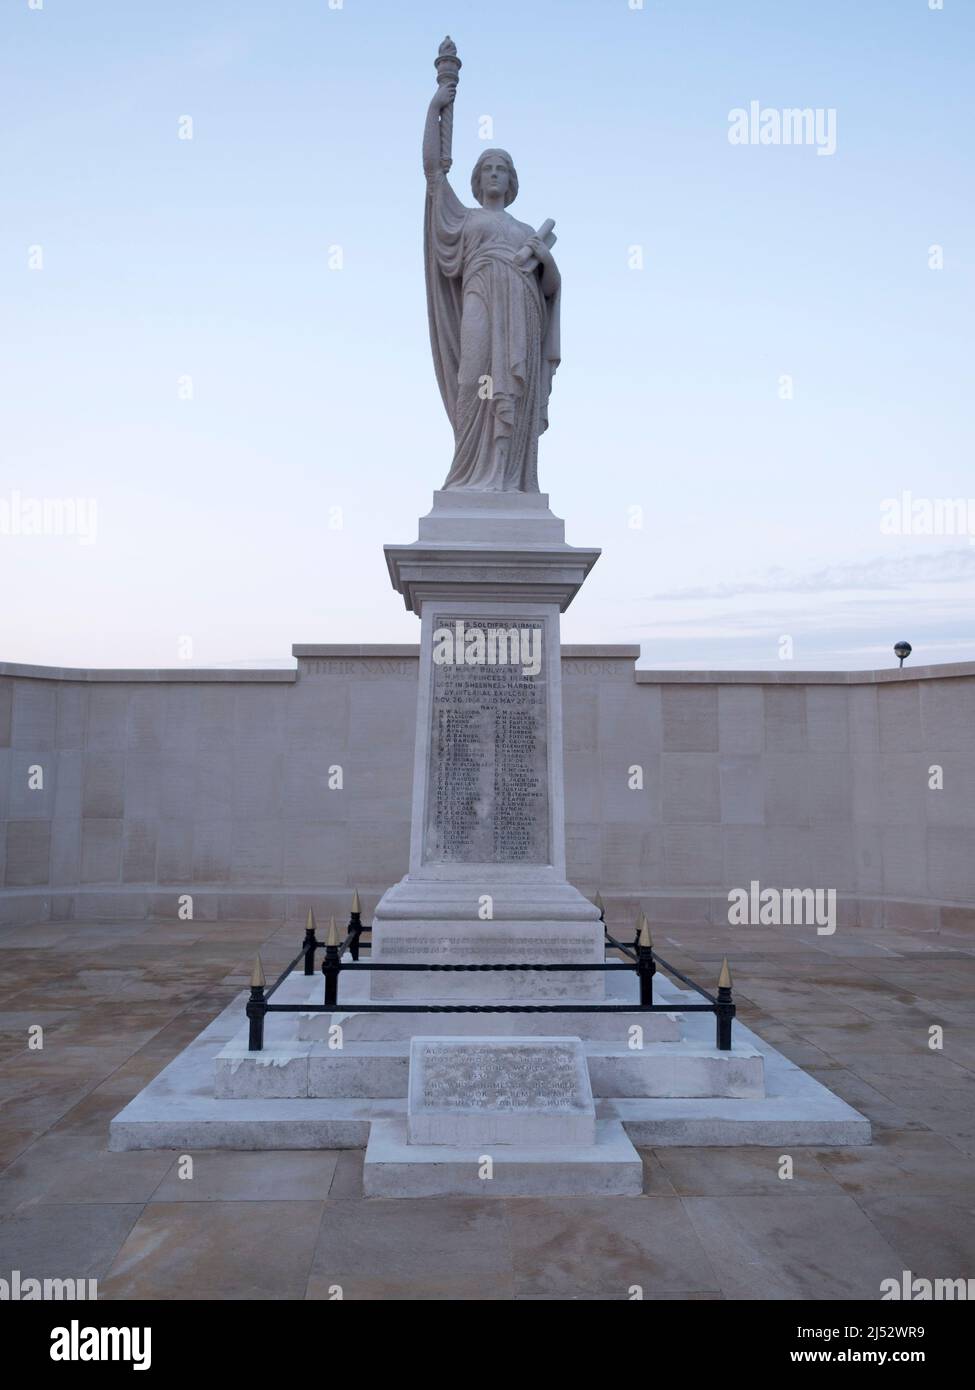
423 38 562 492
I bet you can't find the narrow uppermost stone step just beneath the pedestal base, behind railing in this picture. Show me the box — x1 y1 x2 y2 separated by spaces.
298 1006 682 1047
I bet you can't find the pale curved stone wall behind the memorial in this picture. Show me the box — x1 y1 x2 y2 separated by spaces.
0 645 975 933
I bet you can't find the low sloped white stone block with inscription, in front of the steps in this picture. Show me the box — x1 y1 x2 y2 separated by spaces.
408 1037 595 1148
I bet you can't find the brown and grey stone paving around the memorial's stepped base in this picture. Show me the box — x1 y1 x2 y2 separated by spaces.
0 923 975 1300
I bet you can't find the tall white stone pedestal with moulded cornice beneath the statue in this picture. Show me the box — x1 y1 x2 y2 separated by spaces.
371 488 604 1002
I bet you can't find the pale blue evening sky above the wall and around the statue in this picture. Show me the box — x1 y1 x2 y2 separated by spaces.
0 0 975 670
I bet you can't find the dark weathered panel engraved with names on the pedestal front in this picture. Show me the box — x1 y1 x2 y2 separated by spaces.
424 614 548 863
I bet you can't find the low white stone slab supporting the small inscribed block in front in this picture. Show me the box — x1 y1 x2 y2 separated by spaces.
362 1116 643 1197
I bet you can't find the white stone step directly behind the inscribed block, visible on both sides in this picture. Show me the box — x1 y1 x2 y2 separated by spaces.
216 1039 765 1099
